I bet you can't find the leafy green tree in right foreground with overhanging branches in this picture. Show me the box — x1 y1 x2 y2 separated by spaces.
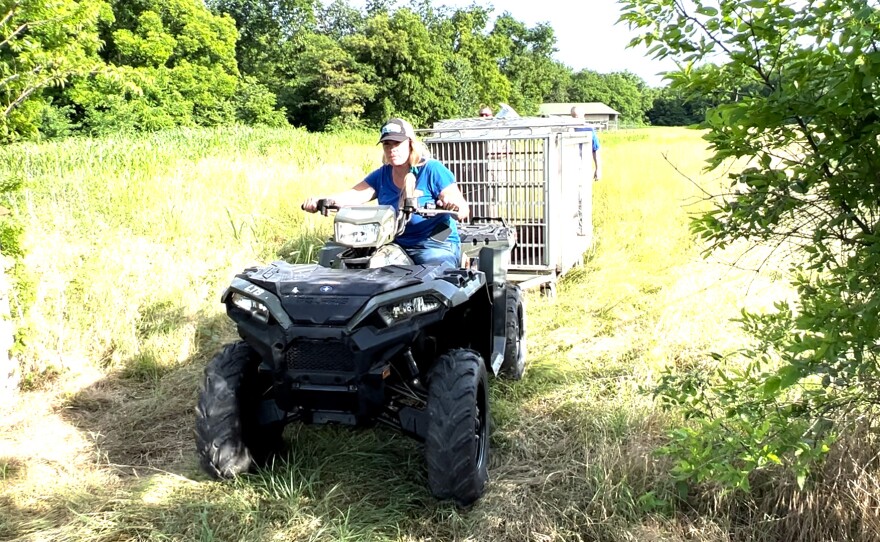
622 0 880 488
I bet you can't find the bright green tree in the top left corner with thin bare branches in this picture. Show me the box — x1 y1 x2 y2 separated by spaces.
0 0 112 142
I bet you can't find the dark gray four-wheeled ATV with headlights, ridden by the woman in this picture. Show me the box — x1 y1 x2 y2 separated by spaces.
196 198 526 506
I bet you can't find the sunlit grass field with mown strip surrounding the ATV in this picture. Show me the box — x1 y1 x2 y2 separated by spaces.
0 128 876 542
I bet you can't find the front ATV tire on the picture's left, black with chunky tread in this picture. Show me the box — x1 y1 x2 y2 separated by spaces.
196 341 284 478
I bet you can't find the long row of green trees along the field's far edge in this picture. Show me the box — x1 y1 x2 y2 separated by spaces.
0 0 705 142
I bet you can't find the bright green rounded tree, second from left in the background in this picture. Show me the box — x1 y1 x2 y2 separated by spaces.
67 0 241 133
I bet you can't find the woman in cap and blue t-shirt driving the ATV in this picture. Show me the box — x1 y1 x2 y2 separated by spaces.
302 118 470 267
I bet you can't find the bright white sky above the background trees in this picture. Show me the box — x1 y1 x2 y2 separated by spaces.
334 0 675 87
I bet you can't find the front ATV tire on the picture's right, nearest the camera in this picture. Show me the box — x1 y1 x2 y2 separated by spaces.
425 350 489 506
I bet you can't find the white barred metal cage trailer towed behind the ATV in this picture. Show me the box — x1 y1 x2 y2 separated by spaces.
420 117 593 295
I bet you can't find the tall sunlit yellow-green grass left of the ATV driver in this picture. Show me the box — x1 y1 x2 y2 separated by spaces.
0 128 379 382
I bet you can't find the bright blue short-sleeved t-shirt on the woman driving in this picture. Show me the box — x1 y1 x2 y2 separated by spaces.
364 159 460 248
